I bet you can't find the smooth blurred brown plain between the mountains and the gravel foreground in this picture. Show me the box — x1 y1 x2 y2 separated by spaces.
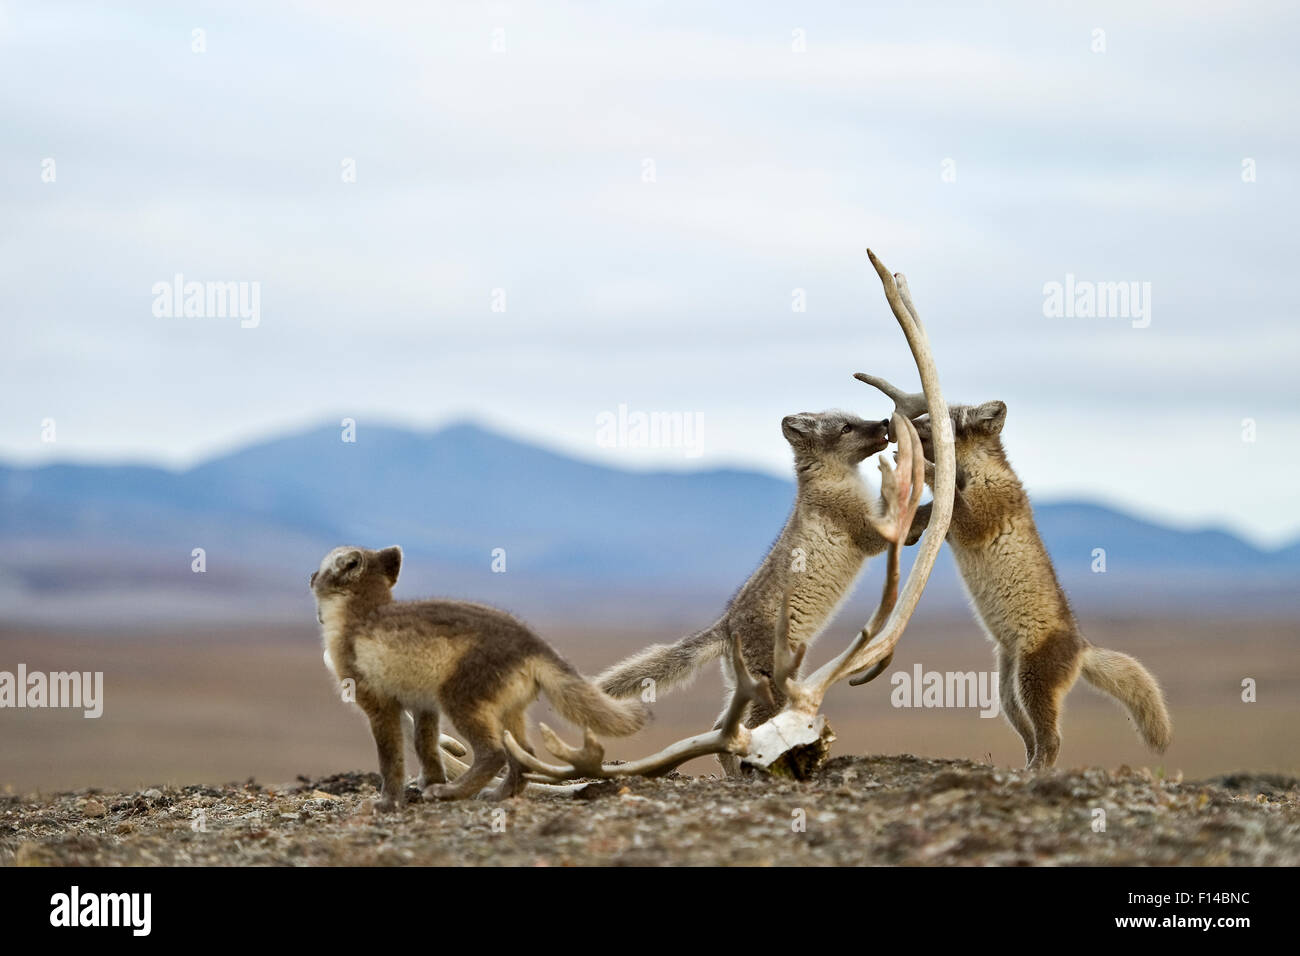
0 615 1300 793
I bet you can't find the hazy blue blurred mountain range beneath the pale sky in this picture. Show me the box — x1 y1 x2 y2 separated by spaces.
0 424 1300 630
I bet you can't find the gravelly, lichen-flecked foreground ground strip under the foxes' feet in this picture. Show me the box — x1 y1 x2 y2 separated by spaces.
0 756 1300 866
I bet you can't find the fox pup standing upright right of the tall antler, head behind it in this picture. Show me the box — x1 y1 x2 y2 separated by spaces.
858 376 1173 769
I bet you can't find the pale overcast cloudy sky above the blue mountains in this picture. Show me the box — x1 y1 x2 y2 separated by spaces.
0 0 1300 542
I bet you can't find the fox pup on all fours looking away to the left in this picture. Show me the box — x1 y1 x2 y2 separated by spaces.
311 548 646 810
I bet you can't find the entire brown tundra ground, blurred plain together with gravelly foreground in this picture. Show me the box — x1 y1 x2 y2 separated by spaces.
0 617 1300 865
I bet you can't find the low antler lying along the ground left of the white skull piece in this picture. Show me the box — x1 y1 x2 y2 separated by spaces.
504 635 775 782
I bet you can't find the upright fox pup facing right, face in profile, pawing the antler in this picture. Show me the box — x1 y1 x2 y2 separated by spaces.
595 411 924 773
